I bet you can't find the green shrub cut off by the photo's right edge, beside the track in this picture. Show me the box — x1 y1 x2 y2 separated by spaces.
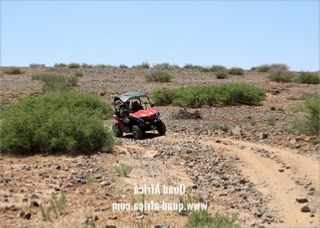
287 93 320 135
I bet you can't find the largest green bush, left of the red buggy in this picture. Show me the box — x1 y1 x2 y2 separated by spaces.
1 91 113 155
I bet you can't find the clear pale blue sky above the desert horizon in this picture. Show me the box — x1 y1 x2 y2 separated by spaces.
1 1 319 71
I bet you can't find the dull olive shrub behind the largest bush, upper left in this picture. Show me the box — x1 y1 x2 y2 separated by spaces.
31 74 79 93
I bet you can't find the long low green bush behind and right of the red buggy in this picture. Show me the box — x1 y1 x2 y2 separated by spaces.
152 83 266 108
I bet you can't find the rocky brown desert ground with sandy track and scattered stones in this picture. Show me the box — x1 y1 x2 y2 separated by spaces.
0 68 319 227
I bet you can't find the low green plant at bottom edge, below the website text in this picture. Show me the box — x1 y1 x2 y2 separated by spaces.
185 210 240 228
